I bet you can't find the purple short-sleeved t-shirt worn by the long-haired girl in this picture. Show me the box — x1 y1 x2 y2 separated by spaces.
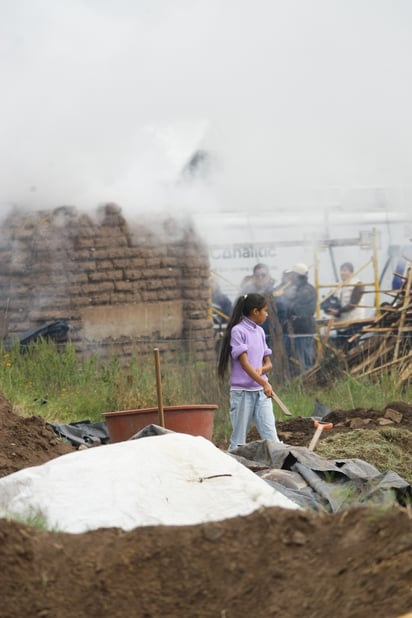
229 318 272 391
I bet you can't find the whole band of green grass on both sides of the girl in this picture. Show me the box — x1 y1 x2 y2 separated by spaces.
0 340 412 442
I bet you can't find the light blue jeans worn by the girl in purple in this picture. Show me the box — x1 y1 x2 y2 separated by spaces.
229 389 279 449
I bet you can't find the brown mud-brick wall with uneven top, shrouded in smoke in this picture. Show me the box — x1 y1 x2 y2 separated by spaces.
0 204 214 363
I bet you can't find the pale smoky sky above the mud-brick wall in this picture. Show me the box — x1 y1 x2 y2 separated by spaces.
0 0 412 211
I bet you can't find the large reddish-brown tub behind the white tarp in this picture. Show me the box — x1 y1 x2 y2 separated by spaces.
102 404 217 442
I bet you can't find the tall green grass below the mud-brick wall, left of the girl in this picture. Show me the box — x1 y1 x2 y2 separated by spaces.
0 340 228 422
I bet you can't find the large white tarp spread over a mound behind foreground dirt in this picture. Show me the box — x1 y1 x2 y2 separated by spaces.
0 433 300 533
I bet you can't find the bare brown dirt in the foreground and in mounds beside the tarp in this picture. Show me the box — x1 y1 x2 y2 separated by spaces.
0 397 412 618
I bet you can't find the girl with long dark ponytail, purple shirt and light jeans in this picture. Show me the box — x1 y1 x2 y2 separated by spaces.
218 293 279 449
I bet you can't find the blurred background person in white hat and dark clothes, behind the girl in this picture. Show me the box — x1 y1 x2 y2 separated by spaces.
286 263 317 371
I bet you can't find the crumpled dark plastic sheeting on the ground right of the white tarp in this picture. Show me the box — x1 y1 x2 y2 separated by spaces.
229 440 412 513
